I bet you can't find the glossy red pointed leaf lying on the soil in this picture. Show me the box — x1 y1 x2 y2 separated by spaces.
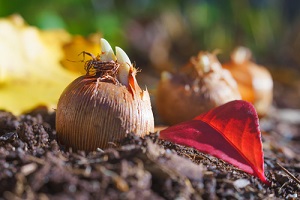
160 100 270 185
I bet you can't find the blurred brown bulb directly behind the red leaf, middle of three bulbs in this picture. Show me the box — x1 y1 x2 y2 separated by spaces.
156 52 241 124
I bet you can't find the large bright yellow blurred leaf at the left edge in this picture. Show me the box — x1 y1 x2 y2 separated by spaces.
0 15 78 115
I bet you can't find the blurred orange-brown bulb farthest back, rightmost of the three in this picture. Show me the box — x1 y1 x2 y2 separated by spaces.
223 47 273 117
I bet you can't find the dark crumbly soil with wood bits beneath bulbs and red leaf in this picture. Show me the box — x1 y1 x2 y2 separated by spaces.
0 105 300 200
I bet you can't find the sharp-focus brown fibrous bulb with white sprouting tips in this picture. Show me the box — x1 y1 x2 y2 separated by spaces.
56 39 154 151
